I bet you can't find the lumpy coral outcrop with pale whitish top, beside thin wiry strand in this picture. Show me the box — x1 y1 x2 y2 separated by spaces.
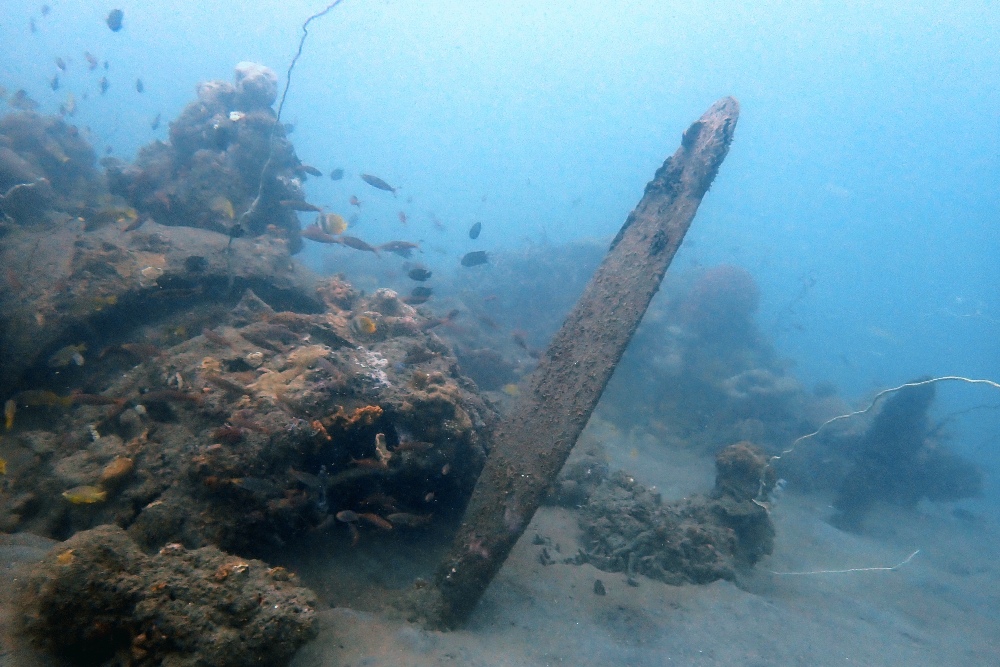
105 62 305 252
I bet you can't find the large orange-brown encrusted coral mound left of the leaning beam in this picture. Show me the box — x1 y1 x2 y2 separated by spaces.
0 279 495 555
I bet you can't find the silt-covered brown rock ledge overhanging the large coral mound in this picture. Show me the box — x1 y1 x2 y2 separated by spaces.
0 206 321 396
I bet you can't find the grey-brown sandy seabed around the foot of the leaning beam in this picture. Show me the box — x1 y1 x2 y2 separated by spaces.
293 426 1000 667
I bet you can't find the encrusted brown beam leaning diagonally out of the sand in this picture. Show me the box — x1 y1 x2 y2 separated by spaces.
428 97 739 627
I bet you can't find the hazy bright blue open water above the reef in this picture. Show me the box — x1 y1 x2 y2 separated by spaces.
0 0 1000 488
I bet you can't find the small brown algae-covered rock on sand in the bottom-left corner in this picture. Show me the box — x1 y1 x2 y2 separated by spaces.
21 526 316 667
